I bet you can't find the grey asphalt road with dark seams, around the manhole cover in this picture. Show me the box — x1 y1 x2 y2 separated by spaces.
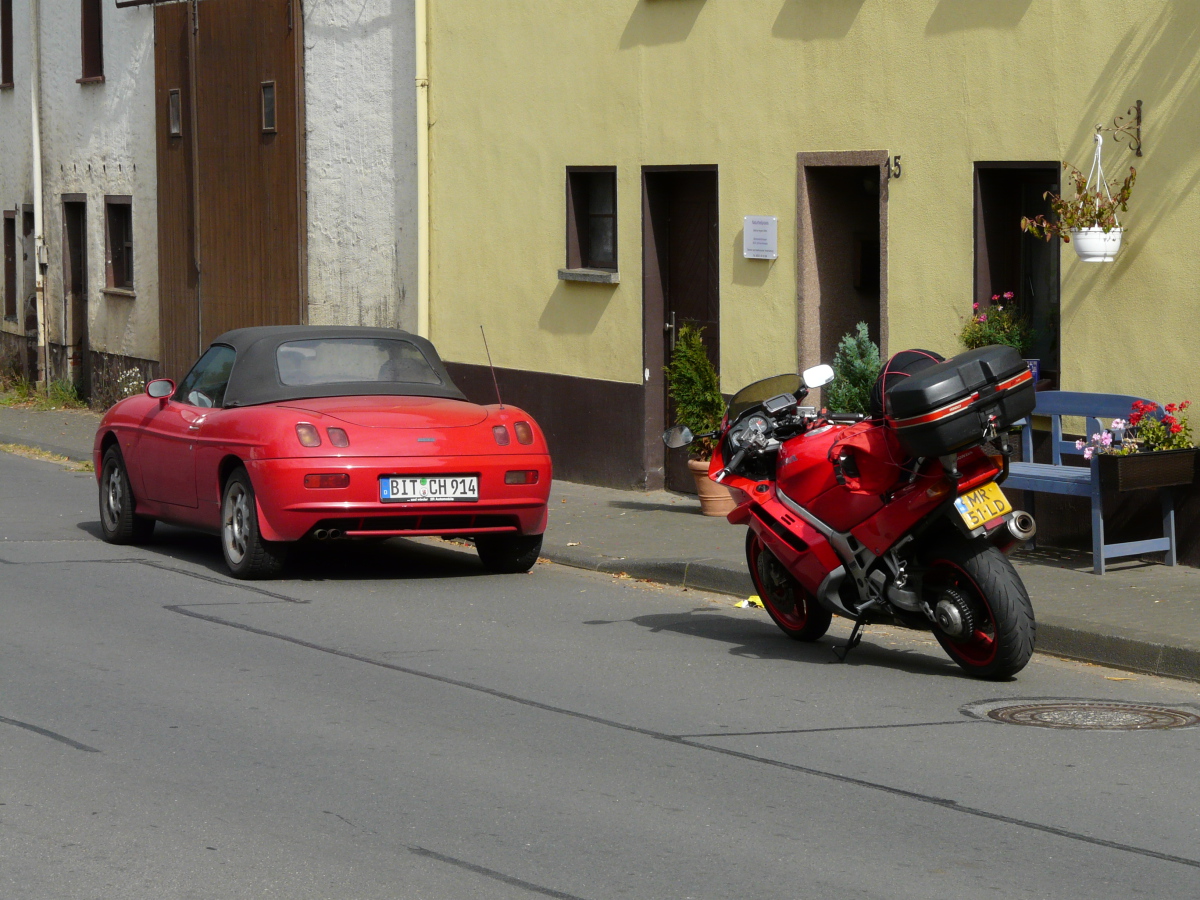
7 454 1200 900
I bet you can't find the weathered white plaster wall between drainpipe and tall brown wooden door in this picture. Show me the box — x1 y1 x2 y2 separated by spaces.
39 0 158 374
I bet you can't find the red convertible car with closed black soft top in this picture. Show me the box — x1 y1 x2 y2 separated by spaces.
94 325 551 578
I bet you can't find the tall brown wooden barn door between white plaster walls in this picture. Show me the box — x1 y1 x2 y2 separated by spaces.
155 0 305 378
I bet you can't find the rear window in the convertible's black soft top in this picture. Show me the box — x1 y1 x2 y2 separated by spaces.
275 337 442 385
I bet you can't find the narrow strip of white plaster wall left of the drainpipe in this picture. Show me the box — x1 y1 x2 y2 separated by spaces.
0 1 34 343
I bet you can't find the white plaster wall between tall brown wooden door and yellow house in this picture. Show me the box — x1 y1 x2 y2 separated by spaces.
304 0 416 330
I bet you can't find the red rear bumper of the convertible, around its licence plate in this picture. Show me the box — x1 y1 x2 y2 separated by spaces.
253 454 551 541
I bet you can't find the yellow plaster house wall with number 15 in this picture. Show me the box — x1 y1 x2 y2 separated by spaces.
430 0 1200 408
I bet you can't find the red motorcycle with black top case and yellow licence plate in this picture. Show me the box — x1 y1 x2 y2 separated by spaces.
662 347 1037 679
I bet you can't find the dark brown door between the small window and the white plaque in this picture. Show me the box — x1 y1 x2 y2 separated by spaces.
646 169 721 493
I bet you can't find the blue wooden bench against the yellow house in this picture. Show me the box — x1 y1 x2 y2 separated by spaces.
1004 391 1176 575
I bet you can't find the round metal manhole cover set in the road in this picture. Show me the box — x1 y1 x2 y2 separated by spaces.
961 698 1200 731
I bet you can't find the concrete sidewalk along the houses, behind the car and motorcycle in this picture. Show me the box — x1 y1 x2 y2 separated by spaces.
0 407 1200 680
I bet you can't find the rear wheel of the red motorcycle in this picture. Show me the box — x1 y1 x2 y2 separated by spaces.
924 538 1037 680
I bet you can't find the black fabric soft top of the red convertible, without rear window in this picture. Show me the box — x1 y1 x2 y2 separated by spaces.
212 325 467 407
